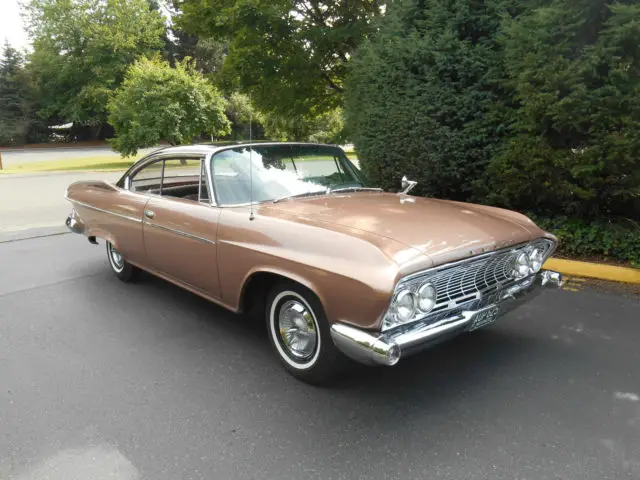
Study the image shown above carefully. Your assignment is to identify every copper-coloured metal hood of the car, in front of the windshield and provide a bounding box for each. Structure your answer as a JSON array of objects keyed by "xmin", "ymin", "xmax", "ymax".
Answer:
[{"xmin": 269, "ymin": 192, "xmax": 545, "ymax": 265}]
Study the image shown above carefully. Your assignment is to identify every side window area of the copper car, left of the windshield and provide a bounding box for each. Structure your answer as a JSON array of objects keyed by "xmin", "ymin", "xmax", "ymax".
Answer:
[{"xmin": 130, "ymin": 158, "xmax": 210, "ymax": 203}]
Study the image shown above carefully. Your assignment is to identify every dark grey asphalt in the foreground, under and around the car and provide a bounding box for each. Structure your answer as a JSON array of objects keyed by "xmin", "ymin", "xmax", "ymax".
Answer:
[{"xmin": 0, "ymin": 235, "xmax": 640, "ymax": 480}]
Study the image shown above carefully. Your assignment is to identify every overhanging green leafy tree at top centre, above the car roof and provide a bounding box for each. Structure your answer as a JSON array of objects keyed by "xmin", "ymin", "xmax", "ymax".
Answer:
[{"xmin": 174, "ymin": 0, "xmax": 384, "ymax": 117}]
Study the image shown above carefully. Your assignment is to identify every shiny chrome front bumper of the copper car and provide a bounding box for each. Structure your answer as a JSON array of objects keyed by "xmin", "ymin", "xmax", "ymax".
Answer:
[{"xmin": 331, "ymin": 270, "xmax": 562, "ymax": 365}]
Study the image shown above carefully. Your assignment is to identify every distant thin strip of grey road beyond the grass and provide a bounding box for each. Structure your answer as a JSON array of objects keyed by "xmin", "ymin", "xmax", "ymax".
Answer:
[{"xmin": 0, "ymin": 147, "xmax": 159, "ymax": 168}]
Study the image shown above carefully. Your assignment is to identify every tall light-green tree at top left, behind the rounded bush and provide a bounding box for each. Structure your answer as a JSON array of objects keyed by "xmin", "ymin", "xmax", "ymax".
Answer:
[{"xmin": 25, "ymin": 0, "xmax": 165, "ymax": 134}]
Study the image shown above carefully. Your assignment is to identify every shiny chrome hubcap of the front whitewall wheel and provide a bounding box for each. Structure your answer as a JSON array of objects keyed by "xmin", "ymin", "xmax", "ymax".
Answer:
[{"xmin": 278, "ymin": 300, "xmax": 318, "ymax": 359}]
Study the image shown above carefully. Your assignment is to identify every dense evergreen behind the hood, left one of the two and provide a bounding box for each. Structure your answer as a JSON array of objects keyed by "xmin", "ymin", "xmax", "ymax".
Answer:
[{"xmin": 345, "ymin": 0, "xmax": 515, "ymax": 199}]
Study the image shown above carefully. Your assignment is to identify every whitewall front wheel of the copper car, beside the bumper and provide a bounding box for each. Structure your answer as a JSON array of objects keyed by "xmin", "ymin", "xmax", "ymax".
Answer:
[{"xmin": 266, "ymin": 282, "xmax": 345, "ymax": 384}]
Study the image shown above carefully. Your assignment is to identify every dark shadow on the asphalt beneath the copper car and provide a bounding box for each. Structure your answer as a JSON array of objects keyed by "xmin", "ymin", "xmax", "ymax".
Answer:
[{"xmin": 136, "ymin": 268, "xmax": 552, "ymax": 400}]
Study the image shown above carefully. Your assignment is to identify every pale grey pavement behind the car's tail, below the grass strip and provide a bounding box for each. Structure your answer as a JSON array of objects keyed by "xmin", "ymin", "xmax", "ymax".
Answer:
[{"xmin": 0, "ymin": 172, "xmax": 122, "ymax": 241}]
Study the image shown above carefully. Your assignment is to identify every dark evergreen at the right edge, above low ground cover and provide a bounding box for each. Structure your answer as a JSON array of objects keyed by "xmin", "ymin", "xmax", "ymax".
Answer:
[{"xmin": 487, "ymin": 0, "xmax": 640, "ymax": 219}]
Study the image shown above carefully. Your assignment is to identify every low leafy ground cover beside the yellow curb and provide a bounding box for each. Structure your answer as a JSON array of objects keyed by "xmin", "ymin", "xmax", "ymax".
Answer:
[{"xmin": 529, "ymin": 215, "xmax": 640, "ymax": 267}]
